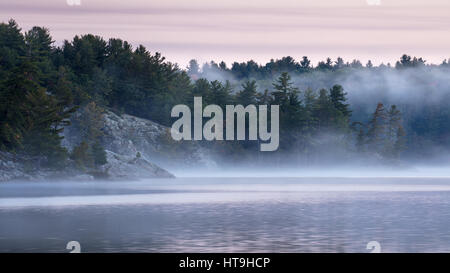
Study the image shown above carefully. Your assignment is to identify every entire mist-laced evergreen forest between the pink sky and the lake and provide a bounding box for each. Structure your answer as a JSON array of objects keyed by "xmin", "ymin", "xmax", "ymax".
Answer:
[{"xmin": 0, "ymin": 20, "xmax": 450, "ymax": 181}]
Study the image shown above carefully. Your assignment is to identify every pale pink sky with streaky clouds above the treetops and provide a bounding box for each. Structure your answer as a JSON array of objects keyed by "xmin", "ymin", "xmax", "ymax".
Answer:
[{"xmin": 0, "ymin": 0, "xmax": 450, "ymax": 68}]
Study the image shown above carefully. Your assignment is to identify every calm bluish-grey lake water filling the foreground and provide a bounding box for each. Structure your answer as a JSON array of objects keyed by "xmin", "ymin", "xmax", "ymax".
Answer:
[{"xmin": 0, "ymin": 178, "xmax": 450, "ymax": 252}]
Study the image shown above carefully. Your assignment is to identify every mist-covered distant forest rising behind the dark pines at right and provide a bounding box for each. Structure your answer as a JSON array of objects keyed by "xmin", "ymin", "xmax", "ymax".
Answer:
[{"xmin": 190, "ymin": 54, "xmax": 450, "ymax": 162}]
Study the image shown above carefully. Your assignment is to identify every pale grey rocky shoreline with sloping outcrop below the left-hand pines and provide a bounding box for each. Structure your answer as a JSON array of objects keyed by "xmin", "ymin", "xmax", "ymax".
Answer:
[{"xmin": 0, "ymin": 107, "xmax": 221, "ymax": 182}]
